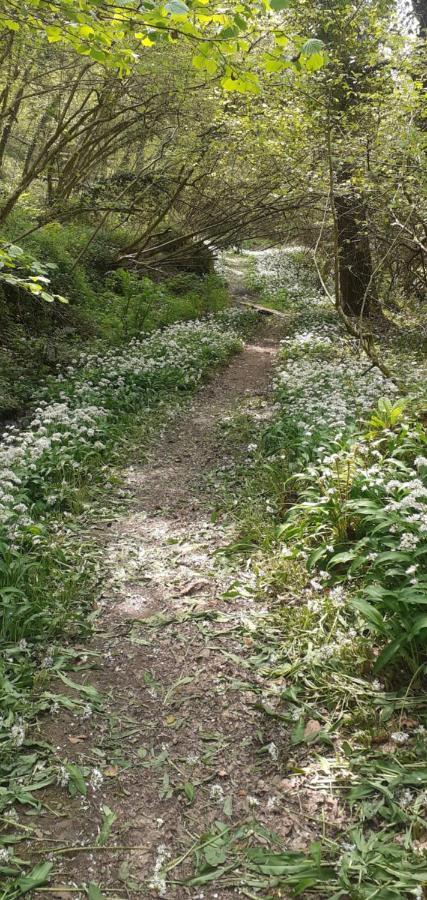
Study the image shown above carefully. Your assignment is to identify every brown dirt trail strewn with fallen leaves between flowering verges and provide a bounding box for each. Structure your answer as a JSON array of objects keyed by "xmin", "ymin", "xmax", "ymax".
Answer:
[{"xmin": 30, "ymin": 321, "xmax": 310, "ymax": 900}]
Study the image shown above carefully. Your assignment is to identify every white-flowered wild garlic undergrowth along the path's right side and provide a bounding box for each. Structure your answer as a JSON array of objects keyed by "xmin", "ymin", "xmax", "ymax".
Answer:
[{"xmin": 198, "ymin": 251, "xmax": 427, "ymax": 900}]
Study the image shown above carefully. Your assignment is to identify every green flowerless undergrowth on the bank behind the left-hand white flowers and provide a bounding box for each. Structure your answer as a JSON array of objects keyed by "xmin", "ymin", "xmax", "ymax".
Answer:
[{"xmin": 0, "ymin": 208, "xmax": 227, "ymax": 420}]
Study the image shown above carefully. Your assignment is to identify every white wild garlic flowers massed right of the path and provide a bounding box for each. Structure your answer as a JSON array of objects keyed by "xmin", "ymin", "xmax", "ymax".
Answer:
[{"xmin": 247, "ymin": 249, "xmax": 427, "ymax": 564}]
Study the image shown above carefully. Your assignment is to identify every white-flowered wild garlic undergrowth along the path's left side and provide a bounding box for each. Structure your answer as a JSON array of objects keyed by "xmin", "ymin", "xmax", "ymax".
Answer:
[{"xmin": 0, "ymin": 309, "xmax": 257, "ymax": 898}]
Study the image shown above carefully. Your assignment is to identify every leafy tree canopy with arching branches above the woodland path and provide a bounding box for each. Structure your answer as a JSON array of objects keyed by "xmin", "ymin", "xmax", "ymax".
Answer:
[{"xmin": 0, "ymin": 0, "xmax": 427, "ymax": 315}]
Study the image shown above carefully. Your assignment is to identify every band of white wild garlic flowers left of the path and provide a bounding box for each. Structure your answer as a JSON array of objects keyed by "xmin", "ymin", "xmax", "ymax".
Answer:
[{"xmin": 0, "ymin": 310, "xmax": 247, "ymax": 543}]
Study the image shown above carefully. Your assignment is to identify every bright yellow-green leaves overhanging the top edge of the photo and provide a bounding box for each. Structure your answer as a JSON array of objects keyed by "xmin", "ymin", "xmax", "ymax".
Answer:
[{"xmin": 0, "ymin": 0, "xmax": 325, "ymax": 81}]
